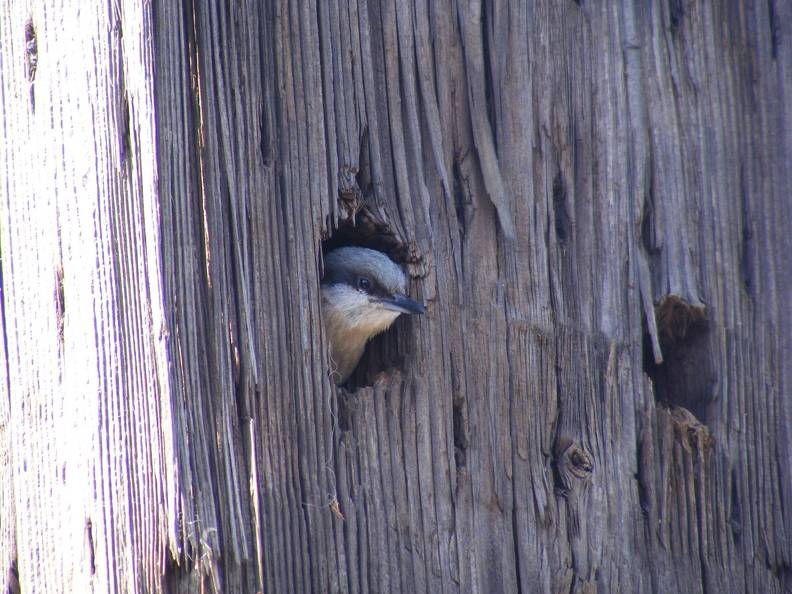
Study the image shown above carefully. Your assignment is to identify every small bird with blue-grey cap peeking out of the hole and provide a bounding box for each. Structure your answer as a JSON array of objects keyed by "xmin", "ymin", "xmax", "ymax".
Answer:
[{"xmin": 321, "ymin": 246, "xmax": 426, "ymax": 385}]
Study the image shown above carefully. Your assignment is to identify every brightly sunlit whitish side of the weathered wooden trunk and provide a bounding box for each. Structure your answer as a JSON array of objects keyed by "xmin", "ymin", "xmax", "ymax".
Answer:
[{"xmin": 0, "ymin": 0, "xmax": 173, "ymax": 594}]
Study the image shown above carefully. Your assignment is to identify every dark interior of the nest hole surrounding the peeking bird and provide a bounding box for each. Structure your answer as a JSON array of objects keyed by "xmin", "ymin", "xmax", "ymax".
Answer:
[{"xmin": 321, "ymin": 207, "xmax": 415, "ymax": 388}]
